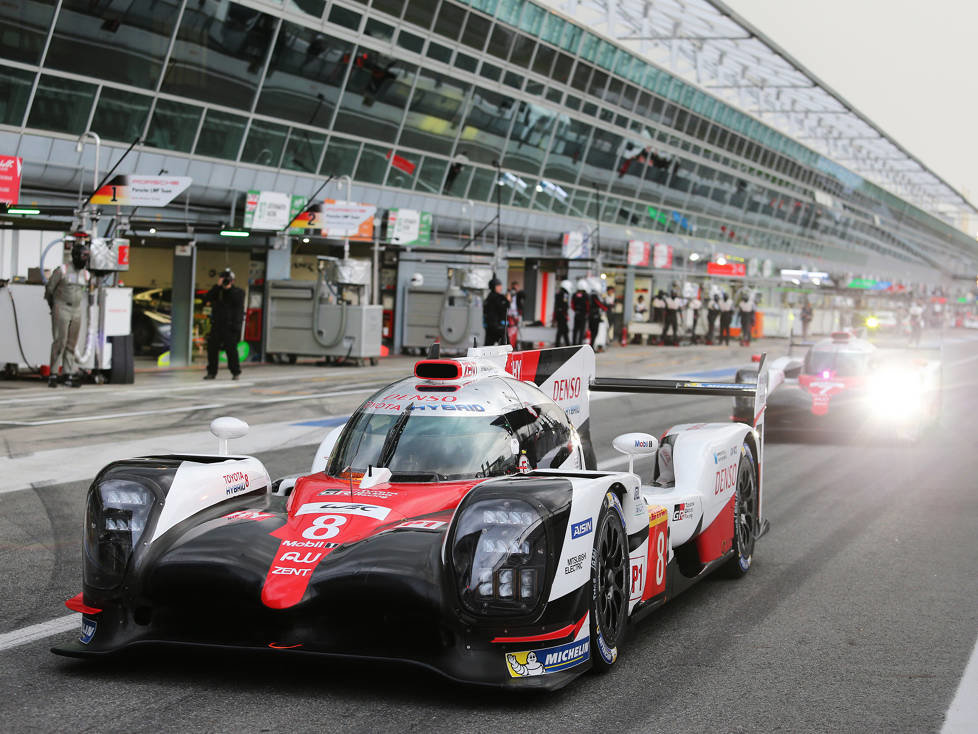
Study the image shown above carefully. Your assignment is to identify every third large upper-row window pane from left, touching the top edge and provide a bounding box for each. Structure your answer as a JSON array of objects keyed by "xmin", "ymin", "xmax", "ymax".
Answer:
[{"xmin": 162, "ymin": 3, "xmax": 278, "ymax": 110}]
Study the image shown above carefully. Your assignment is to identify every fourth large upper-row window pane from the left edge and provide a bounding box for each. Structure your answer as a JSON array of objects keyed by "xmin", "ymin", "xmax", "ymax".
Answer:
[{"xmin": 255, "ymin": 23, "xmax": 353, "ymax": 127}]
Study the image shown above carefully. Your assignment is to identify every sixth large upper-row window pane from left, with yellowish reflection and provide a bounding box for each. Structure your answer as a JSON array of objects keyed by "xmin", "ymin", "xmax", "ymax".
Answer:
[{"xmin": 400, "ymin": 68, "xmax": 469, "ymax": 155}]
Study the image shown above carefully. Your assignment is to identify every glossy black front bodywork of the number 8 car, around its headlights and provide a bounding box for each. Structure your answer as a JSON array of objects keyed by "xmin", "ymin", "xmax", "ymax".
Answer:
[{"xmin": 54, "ymin": 462, "xmax": 590, "ymax": 689}]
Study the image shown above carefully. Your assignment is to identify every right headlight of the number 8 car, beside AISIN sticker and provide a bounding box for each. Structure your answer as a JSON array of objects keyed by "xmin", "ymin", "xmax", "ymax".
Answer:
[{"xmin": 452, "ymin": 499, "xmax": 548, "ymax": 614}]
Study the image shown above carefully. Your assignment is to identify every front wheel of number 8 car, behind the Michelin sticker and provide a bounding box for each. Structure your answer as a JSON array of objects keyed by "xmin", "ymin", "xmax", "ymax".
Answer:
[{"xmin": 588, "ymin": 492, "xmax": 629, "ymax": 673}]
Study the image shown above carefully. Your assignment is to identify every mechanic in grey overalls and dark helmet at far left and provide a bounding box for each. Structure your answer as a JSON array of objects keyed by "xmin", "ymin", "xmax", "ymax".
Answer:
[{"xmin": 44, "ymin": 241, "xmax": 92, "ymax": 387}]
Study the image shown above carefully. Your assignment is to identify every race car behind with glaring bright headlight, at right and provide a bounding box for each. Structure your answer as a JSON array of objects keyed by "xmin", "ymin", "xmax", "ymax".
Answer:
[{"xmin": 733, "ymin": 332, "xmax": 942, "ymax": 440}]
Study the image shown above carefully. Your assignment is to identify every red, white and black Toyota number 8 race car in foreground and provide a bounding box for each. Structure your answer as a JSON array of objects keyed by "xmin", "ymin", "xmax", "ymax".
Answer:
[{"xmin": 53, "ymin": 346, "xmax": 767, "ymax": 689}]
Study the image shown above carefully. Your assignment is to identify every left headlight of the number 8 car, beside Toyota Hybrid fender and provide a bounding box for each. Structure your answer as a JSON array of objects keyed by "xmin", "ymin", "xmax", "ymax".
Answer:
[{"xmin": 84, "ymin": 478, "xmax": 156, "ymax": 589}]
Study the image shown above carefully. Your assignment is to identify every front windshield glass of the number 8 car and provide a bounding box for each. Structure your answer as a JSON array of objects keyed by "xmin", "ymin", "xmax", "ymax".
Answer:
[{"xmin": 329, "ymin": 409, "xmax": 518, "ymax": 482}]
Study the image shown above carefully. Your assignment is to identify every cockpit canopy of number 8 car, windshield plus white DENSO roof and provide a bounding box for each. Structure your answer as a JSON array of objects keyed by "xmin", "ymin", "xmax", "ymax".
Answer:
[{"xmin": 326, "ymin": 377, "xmax": 582, "ymax": 482}]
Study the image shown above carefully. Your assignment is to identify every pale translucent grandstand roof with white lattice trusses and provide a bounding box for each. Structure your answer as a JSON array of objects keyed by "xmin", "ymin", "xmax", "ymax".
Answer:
[{"xmin": 544, "ymin": 0, "xmax": 978, "ymax": 225}]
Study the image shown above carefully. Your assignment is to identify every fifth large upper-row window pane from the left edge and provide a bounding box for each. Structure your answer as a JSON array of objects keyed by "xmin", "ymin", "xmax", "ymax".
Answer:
[{"xmin": 333, "ymin": 46, "xmax": 417, "ymax": 143}]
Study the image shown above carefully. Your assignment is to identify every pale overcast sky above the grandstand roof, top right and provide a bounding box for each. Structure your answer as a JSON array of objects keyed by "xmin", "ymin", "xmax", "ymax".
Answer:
[{"xmin": 725, "ymin": 0, "xmax": 978, "ymax": 217}]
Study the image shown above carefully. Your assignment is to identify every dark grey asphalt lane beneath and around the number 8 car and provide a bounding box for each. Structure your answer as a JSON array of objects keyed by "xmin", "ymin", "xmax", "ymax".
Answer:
[{"xmin": 0, "ymin": 340, "xmax": 978, "ymax": 732}]
